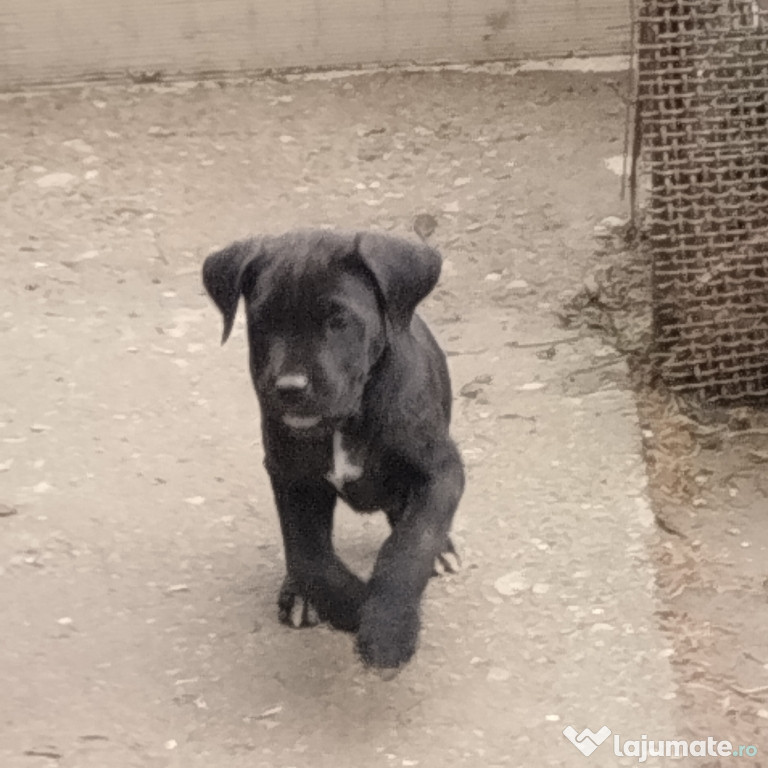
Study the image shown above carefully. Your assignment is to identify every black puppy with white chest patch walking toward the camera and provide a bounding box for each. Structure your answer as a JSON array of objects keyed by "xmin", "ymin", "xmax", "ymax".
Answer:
[{"xmin": 203, "ymin": 230, "xmax": 464, "ymax": 669}]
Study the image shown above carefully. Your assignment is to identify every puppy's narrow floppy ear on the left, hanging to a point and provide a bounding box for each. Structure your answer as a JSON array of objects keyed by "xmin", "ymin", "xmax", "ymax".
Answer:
[{"xmin": 203, "ymin": 234, "xmax": 262, "ymax": 344}]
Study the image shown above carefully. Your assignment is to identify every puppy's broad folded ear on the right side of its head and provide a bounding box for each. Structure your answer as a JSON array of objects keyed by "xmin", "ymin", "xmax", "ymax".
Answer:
[{"xmin": 356, "ymin": 232, "xmax": 442, "ymax": 329}]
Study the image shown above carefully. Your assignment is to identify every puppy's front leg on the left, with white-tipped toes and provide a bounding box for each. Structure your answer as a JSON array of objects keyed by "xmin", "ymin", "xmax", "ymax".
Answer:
[{"xmin": 272, "ymin": 478, "xmax": 365, "ymax": 632}]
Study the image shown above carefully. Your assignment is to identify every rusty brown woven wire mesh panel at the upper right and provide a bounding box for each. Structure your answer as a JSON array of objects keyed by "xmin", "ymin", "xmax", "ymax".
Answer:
[{"xmin": 635, "ymin": 0, "xmax": 768, "ymax": 402}]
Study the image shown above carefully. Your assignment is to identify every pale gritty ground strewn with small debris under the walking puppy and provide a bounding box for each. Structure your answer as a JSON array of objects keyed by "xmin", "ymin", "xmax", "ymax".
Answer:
[{"xmin": 0, "ymin": 73, "xmax": 760, "ymax": 768}]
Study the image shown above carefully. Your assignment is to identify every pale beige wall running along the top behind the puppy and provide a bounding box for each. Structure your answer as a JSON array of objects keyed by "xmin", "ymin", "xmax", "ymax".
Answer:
[{"xmin": 0, "ymin": 0, "xmax": 628, "ymax": 87}]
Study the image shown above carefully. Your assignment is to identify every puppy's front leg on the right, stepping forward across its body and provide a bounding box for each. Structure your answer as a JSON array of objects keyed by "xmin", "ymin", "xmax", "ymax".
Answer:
[{"xmin": 357, "ymin": 445, "xmax": 464, "ymax": 669}]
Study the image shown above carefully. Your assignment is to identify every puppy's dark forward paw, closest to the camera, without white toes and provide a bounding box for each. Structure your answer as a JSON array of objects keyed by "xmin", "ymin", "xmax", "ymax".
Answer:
[{"xmin": 355, "ymin": 599, "xmax": 421, "ymax": 680}]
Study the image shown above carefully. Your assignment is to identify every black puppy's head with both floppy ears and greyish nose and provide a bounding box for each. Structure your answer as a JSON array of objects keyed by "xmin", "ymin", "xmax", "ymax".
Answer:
[{"xmin": 203, "ymin": 230, "xmax": 440, "ymax": 434}]
